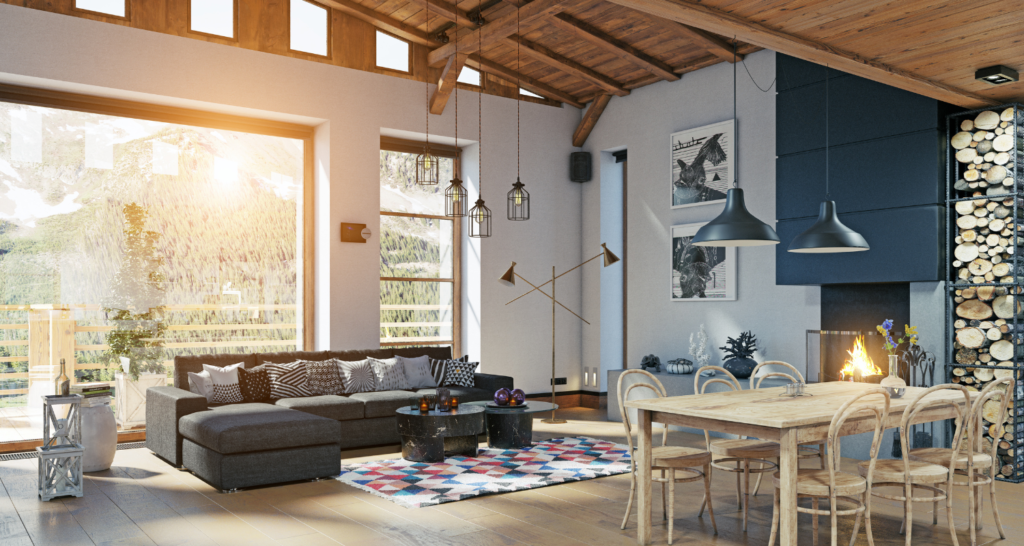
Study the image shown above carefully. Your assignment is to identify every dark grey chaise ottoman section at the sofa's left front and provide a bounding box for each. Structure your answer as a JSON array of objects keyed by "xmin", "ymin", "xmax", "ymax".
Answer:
[{"xmin": 178, "ymin": 404, "xmax": 341, "ymax": 491}]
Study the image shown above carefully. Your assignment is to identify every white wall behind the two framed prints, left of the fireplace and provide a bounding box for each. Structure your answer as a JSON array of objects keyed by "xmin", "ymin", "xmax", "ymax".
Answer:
[{"xmin": 582, "ymin": 51, "xmax": 820, "ymax": 391}]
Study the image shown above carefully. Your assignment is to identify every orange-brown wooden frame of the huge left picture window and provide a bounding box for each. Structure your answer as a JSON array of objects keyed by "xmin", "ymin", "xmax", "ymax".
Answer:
[{"xmin": 0, "ymin": 84, "xmax": 315, "ymax": 350}]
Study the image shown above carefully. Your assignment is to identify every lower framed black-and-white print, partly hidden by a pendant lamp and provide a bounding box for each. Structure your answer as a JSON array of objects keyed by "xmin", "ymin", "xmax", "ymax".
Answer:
[{"xmin": 669, "ymin": 223, "xmax": 737, "ymax": 301}]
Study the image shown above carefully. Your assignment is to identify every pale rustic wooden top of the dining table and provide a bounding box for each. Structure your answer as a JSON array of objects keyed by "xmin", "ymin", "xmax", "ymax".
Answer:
[{"xmin": 626, "ymin": 381, "xmax": 978, "ymax": 429}]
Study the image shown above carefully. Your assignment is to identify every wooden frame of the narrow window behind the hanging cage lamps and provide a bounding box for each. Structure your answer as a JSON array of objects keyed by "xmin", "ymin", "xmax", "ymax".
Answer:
[{"xmin": 378, "ymin": 136, "xmax": 462, "ymax": 358}]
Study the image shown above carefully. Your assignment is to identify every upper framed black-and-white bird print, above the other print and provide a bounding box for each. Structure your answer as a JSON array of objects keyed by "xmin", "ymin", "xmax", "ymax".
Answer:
[{"xmin": 670, "ymin": 120, "xmax": 736, "ymax": 209}]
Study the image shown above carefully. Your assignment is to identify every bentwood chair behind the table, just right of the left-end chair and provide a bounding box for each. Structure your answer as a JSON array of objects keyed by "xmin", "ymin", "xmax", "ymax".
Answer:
[{"xmin": 693, "ymin": 366, "xmax": 780, "ymax": 533}]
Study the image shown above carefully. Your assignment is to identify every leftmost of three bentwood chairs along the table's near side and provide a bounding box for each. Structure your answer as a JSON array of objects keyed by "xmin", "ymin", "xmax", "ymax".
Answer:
[{"xmin": 768, "ymin": 388, "xmax": 889, "ymax": 546}]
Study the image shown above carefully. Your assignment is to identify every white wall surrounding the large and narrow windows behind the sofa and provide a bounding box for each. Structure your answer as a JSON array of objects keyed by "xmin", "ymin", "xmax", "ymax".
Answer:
[{"xmin": 0, "ymin": 4, "xmax": 581, "ymax": 392}]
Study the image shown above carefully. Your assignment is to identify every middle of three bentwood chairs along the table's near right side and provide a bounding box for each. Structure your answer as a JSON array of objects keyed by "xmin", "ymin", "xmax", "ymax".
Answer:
[{"xmin": 858, "ymin": 384, "xmax": 975, "ymax": 546}]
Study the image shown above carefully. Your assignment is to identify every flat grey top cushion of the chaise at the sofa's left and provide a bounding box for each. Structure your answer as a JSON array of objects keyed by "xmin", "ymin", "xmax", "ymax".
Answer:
[{"xmin": 178, "ymin": 404, "xmax": 341, "ymax": 454}]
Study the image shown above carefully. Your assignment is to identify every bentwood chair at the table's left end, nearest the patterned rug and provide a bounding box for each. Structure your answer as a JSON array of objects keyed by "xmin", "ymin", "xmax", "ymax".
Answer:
[{"xmin": 615, "ymin": 370, "xmax": 718, "ymax": 544}]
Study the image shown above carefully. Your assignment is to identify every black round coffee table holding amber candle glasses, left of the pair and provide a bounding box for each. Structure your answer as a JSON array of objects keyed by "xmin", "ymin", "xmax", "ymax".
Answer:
[{"xmin": 395, "ymin": 405, "xmax": 484, "ymax": 463}]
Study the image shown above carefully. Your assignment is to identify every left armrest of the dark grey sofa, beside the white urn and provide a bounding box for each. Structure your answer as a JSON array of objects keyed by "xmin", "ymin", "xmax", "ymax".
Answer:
[{"xmin": 145, "ymin": 387, "xmax": 209, "ymax": 466}]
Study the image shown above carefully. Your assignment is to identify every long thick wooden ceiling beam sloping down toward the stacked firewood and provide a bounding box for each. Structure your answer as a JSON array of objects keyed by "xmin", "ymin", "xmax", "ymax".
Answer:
[{"xmin": 607, "ymin": 0, "xmax": 999, "ymax": 108}]
